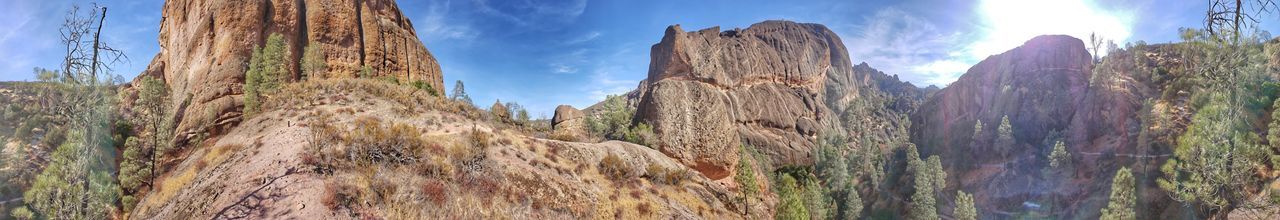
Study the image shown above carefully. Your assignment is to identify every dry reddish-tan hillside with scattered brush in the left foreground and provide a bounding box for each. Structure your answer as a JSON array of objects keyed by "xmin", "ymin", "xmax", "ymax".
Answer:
[{"xmin": 132, "ymin": 79, "xmax": 752, "ymax": 219}]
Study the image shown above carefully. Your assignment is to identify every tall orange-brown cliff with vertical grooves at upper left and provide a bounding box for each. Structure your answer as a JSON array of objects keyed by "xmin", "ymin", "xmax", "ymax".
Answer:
[{"xmin": 135, "ymin": 0, "xmax": 444, "ymax": 145}]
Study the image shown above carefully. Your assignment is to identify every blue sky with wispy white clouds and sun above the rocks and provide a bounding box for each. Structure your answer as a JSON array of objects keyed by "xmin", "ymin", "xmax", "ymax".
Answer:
[{"xmin": 0, "ymin": 0, "xmax": 1277, "ymax": 118}]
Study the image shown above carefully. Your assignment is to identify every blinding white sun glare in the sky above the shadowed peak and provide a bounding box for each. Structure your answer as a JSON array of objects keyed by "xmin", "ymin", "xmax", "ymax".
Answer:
[{"xmin": 969, "ymin": 0, "xmax": 1133, "ymax": 58}]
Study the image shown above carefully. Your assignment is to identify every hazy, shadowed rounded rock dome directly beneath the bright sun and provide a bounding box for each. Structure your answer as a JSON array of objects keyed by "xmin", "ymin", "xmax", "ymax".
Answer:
[{"xmin": 911, "ymin": 36, "xmax": 1093, "ymax": 217}]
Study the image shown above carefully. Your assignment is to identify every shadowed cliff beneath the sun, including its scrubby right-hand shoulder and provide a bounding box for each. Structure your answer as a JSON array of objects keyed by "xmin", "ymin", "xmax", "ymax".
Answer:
[{"xmin": 911, "ymin": 36, "xmax": 1190, "ymax": 219}]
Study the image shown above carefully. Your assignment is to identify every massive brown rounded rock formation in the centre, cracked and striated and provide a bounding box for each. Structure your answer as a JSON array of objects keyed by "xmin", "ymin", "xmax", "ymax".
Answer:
[{"xmin": 636, "ymin": 20, "xmax": 863, "ymax": 179}]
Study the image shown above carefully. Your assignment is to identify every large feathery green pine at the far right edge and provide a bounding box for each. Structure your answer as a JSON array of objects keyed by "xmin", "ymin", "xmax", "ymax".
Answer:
[{"xmin": 1157, "ymin": 29, "xmax": 1275, "ymax": 217}]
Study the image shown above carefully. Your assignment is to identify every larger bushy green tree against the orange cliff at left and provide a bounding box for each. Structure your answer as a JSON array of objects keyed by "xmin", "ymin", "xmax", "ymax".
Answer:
[{"xmin": 244, "ymin": 33, "xmax": 289, "ymax": 115}]
